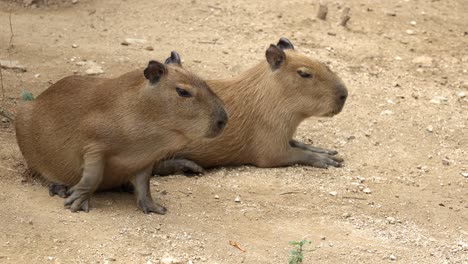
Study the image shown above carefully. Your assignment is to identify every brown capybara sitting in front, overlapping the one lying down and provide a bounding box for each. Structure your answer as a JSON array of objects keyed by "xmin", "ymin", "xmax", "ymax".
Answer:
[{"xmin": 15, "ymin": 52, "xmax": 227, "ymax": 214}]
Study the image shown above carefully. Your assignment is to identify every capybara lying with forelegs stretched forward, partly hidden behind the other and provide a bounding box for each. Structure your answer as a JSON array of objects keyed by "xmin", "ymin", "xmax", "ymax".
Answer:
[{"xmin": 154, "ymin": 38, "xmax": 348, "ymax": 175}]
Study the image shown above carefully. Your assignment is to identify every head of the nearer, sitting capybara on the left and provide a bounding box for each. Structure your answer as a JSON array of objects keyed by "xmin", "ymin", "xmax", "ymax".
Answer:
[{"xmin": 144, "ymin": 51, "xmax": 228, "ymax": 139}]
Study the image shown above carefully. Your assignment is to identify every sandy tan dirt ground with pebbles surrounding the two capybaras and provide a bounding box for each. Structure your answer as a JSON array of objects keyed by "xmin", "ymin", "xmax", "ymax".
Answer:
[{"xmin": 0, "ymin": 0, "xmax": 468, "ymax": 264}]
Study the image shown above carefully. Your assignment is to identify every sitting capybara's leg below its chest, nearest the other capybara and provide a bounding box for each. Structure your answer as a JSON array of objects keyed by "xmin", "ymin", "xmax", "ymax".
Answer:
[{"xmin": 131, "ymin": 168, "xmax": 167, "ymax": 214}]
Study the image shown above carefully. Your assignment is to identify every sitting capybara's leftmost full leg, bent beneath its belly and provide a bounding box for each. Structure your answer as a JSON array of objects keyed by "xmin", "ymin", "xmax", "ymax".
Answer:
[{"xmin": 65, "ymin": 153, "xmax": 104, "ymax": 212}]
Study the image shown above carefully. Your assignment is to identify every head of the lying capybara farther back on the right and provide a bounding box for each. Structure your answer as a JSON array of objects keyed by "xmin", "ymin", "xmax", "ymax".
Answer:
[{"xmin": 266, "ymin": 38, "xmax": 348, "ymax": 117}]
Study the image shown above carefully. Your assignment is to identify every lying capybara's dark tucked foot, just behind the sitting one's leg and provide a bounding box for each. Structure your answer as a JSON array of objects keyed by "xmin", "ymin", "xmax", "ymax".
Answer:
[{"xmin": 153, "ymin": 159, "xmax": 204, "ymax": 176}]
